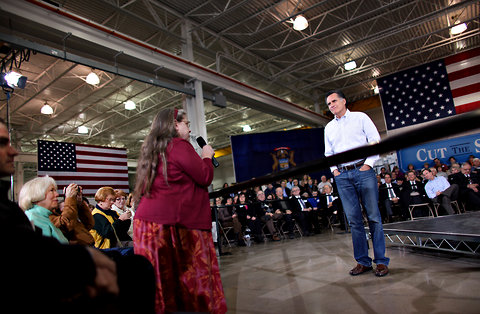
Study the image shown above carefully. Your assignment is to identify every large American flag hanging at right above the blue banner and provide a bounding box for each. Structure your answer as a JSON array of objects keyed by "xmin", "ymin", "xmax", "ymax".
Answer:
[{"xmin": 377, "ymin": 48, "xmax": 480, "ymax": 130}]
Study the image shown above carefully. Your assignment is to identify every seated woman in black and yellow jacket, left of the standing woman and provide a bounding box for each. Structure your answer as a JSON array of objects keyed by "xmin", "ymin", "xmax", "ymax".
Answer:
[{"xmin": 90, "ymin": 187, "xmax": 132, "ymax": 249}]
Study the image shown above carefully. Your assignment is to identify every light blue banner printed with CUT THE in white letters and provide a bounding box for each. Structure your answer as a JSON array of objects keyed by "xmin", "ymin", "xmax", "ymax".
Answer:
[{"xmin": 397, "ymin": 133, "xmax": 480, "ymax": 171}]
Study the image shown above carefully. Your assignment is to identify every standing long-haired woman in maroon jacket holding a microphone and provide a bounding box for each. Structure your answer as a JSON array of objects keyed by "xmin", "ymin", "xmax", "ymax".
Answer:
[{"xmin": 133, "ymin": 109, "xmax": 227, "ymax": 313}]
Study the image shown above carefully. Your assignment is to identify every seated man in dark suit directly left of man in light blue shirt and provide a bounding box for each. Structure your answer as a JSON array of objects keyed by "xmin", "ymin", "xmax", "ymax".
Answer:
[{"xmin": 400, "ymin": 170, "xmax": 428, "ymax": 219}]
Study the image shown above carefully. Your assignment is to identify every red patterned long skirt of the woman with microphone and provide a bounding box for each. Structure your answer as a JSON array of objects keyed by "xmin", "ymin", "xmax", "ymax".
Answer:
[{"xmin": 133, "ymin": 219, "xmax": 227, "ymax": 313}]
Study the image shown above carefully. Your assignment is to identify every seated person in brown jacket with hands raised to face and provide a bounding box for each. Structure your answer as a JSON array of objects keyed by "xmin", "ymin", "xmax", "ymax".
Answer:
[{"xmin": 49, "ymin": 183, "xmax": 95, "ymax": 246}]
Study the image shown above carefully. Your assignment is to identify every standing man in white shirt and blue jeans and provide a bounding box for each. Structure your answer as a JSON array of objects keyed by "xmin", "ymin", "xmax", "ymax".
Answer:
[{"xmin": 325, "ymin": 90, "xmax": 390, "ymax": 277}]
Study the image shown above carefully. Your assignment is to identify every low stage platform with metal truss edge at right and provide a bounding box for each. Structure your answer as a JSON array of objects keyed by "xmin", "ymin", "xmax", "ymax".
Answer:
[{"xmin": 367, "ymin": 212, "xmax": 480, "ymax": 256}]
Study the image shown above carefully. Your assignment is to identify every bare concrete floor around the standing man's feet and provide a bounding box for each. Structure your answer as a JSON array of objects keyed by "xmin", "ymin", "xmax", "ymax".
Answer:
[{"xmin": 219, "ymin": 230, "xmax": 480, "ymax": 314}]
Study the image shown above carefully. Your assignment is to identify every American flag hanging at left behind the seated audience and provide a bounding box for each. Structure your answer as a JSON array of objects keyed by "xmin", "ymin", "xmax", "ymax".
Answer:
[{"xmin": 38, "ymin": 140, "xmax": 129, "ymax": 196}]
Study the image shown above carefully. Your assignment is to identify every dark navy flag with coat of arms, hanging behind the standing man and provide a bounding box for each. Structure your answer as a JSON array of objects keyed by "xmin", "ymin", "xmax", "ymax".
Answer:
[{"xmin": 231, "ymin": 128, "xmax": 330, "ymax": 182}]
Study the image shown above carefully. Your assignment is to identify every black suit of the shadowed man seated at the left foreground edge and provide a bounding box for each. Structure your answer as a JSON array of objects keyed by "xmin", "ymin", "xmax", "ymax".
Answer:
[{"xmin": 0, "ymin": 182, "xmax": 96, "ymax": 313}]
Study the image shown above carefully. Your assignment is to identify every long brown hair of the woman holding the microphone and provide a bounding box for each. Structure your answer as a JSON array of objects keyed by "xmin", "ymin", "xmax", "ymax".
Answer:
[{"xmin": 133, "ymin": 109, "xmax": 185, "ymax": 205}]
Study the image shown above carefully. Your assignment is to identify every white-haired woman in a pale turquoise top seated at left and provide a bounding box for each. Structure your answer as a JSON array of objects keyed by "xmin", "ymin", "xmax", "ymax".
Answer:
[{"xmin": 18, "ymin": 176, "xmax": 68, "ymax": 244}]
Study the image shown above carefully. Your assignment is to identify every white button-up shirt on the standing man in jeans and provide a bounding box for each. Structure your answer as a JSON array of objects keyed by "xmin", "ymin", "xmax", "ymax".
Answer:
[{"xmin": 325, "ymin": 109, "xmax": 380, "ymax": 172}]
